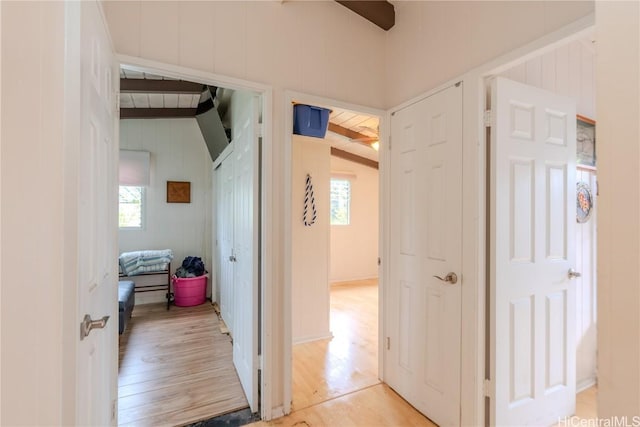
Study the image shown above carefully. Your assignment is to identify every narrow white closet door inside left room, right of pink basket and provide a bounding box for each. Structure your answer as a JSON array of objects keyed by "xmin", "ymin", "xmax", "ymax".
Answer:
[{"xmin": 216, "ymin": 153, "xmax": 234, "ymax": 334}]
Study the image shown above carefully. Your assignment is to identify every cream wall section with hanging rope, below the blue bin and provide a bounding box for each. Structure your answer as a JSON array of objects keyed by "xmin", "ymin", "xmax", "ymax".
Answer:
[{"xmin": 291, "ymin": 135, "xmax": 331, "ymax": 343}]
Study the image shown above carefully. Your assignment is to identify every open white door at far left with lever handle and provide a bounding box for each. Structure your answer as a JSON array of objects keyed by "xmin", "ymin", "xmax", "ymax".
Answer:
[{"xmin": 75, "ymin": 2, "xmax": 118, "ymax": 425}]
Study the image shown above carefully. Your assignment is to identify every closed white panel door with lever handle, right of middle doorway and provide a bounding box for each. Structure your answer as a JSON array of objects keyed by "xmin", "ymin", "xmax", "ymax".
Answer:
[{"xmin": 385, "ymin": 84, "xmax": 462, "ymax": 426}]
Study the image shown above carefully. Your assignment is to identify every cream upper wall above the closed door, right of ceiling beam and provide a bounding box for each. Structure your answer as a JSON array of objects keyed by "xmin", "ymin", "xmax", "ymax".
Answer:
[{"xmin": 385, "ymin": 1, "xmax": 593, "ymax": 107}]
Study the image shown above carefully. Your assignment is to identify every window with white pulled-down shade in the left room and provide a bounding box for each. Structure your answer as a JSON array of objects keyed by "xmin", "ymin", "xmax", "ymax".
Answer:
[{"xmin": 118, "ymin": 150, "xmax": 150, "ymax": 229}]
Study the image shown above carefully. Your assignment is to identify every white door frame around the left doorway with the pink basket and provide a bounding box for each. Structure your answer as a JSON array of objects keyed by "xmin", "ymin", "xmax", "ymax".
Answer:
[{"xmin": 116, "ymin": 55, "xmax": 278, "ymax": 420}]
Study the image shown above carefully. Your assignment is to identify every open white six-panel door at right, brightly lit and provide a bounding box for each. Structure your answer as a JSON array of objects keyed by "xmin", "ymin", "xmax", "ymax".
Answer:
[{"xmin": 489, "ymin": 78, "xmax": 576, "ymax": 426}]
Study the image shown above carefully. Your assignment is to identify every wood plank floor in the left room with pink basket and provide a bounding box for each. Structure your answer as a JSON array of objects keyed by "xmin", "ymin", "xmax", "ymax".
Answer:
[{"xmin": 118, "ymin": 303, "xmax": 248, "ymax": 426}]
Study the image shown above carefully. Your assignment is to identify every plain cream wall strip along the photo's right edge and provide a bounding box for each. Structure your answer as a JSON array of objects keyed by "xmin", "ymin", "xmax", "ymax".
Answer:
[{"xmin": 596, "ymin": 2, "xmax": 640, "ymax": 423}]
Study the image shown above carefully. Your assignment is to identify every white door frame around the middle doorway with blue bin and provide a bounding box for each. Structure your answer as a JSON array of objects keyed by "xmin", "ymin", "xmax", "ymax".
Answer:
[{"xmin": 282, "ymin": 90, "xmax": 389, "ymax": 415}]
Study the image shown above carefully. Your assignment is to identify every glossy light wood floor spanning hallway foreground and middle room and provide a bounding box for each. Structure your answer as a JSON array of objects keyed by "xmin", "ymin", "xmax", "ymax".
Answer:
[{"xmin": 251, "ymin": 280, "xmax": 434, "ymax": 427}]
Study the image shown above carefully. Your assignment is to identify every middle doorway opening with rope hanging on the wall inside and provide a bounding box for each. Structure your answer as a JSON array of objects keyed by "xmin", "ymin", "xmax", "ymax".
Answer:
[{"xmin": 289, "ymin": 96, "xmax": 380, "ymax": 411}]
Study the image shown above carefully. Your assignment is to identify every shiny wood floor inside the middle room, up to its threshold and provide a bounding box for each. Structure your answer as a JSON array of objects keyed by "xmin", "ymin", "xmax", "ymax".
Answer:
[{"xmin": 292, "ymin": 280, "xmax": 380, "ymax": 411}]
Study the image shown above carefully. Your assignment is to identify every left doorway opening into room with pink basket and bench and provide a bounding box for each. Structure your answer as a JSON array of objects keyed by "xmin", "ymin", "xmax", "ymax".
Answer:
[{"xmin": 118, "ymin": 65, "xmax": 265, "ymax": 425}]
